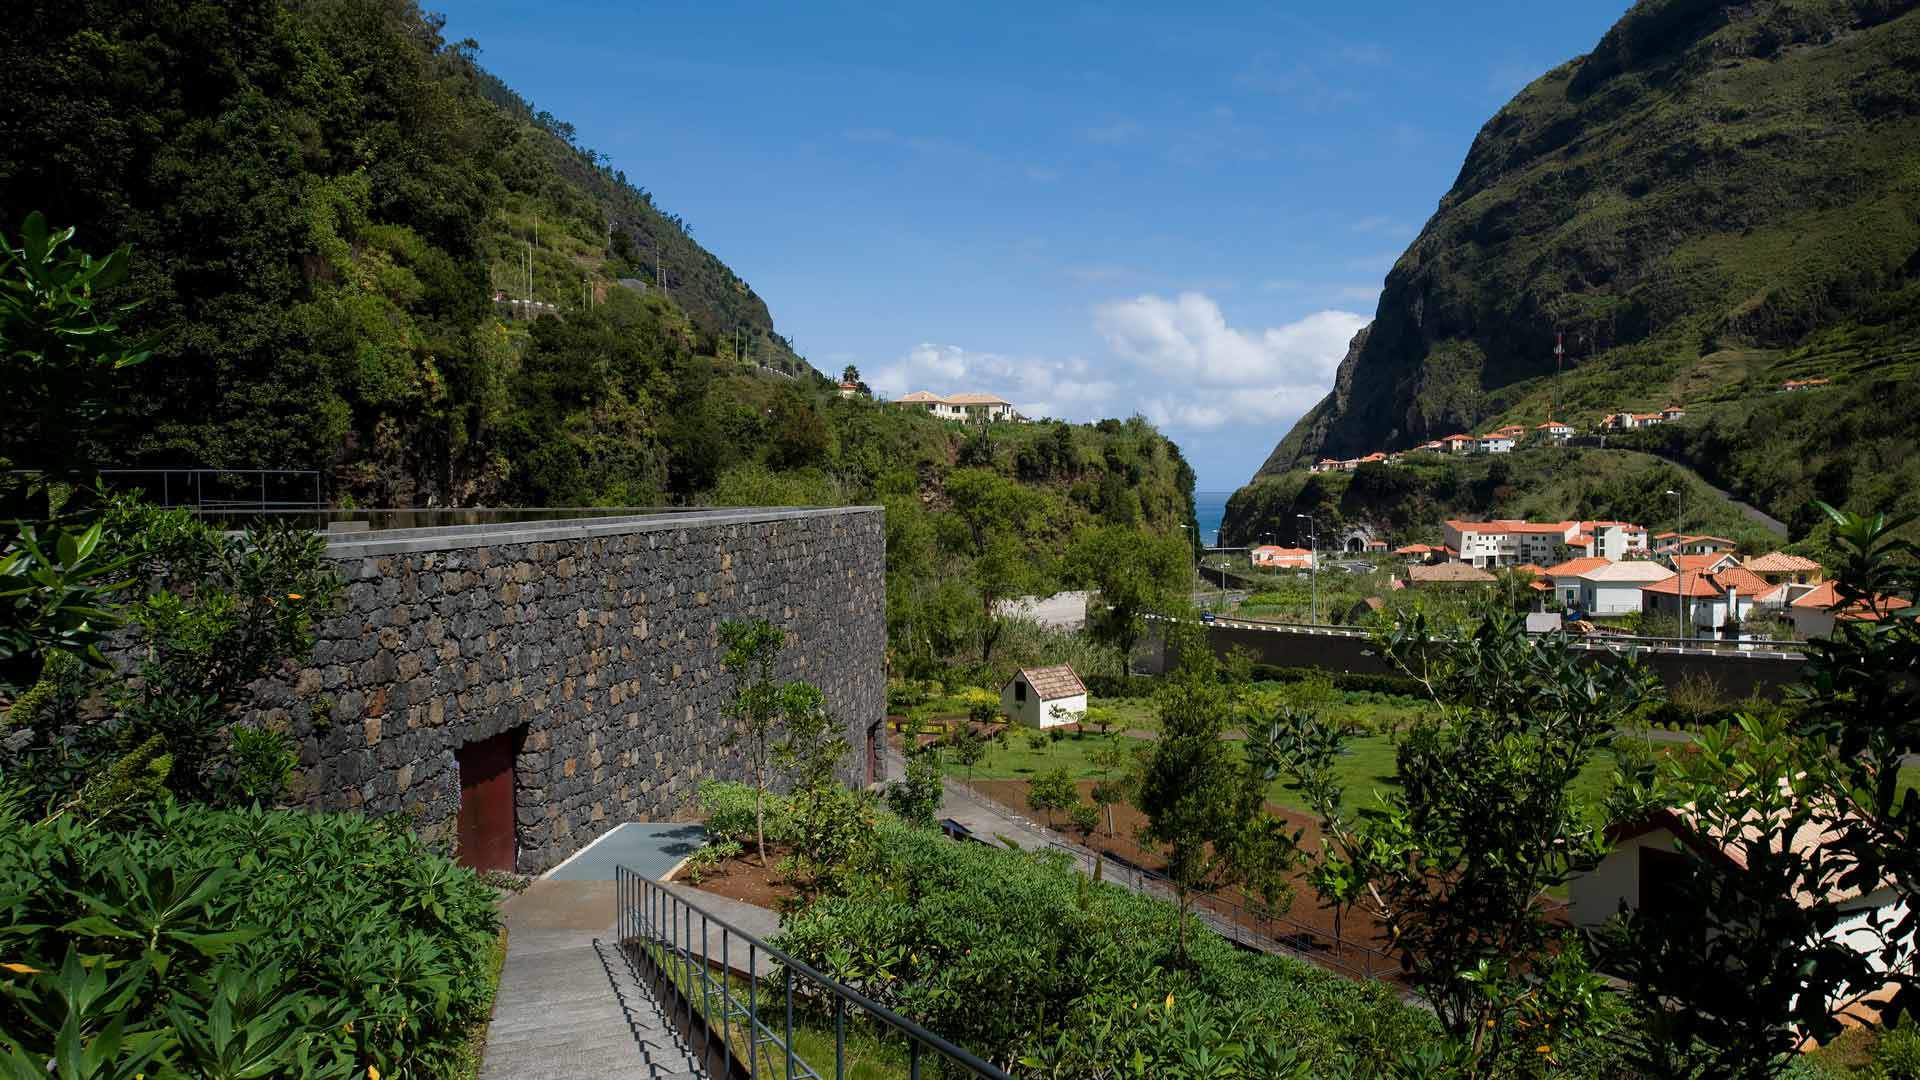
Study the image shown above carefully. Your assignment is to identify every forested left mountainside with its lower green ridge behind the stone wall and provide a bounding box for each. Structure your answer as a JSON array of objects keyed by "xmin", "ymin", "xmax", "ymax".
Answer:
[{"xmin": 0, "ymin": 0, "xmax": 1194, "ymax": 672}]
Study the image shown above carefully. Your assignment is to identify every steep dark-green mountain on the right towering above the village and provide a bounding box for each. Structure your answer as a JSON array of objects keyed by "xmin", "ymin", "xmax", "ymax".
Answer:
[{"xmin": 1260, "ymin": 0, "xmax": 1920, "ymax": 528}]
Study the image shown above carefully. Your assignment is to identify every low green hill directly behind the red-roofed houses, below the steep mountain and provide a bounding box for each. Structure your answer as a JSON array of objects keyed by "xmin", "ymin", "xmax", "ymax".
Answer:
[{"xmin": 1221, "ymin": 448, "xmax": 1780, "ymax": 552}]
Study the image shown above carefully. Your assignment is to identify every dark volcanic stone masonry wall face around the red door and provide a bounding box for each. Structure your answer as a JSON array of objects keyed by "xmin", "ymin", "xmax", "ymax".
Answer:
[{"xmin": 247, "ymin": 507, "xmax": 887, "ymax": 872}]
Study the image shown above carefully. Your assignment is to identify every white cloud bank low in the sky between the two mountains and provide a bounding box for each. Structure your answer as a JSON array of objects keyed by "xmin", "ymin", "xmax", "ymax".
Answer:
[{"xmin": 866, "ymin": 292, "xmax": 1367, "ymax": 432}]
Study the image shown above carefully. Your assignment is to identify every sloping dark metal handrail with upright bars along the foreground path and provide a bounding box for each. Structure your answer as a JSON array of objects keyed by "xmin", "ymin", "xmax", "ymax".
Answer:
[{"xmin": 614, "ymin": 867, "xmax": 1012, "ymax": 1080}]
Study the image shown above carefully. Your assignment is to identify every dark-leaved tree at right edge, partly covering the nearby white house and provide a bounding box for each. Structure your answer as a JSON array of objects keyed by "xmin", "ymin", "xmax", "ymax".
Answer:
[{"xmin": 1607, "ymin": 505, "xmax": 1920, "ymax": 1080}]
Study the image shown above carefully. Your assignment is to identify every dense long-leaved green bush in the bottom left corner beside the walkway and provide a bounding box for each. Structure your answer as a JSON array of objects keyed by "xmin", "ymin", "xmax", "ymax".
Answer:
[{"xmin": 0, "ymin": 801, "xmax": 499, "ymax": 1080}]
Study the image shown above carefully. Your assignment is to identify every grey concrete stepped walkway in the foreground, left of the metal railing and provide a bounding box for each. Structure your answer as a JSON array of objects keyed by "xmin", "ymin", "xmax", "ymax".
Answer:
[{"xmin": 480, "ymin": 914, "xmax": 707, "ymax": 1080}]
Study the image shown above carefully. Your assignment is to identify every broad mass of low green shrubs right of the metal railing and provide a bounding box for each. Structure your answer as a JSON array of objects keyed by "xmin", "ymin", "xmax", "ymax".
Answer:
[{"xmin": 778, "ymin": 822, "xmax": 1436, "ymax": 1076}]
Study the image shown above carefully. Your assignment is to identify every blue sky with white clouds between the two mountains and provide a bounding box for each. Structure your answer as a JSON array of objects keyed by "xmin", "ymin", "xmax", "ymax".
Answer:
[{"xmin": 444, "ymin": 0, "xmax": 1628, "ymax": 490}]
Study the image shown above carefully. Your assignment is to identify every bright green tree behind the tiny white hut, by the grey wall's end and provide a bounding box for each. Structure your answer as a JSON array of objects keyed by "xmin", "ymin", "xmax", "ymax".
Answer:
[{"xmin": 1066, "ymin": 525, "xmax": 1192, "ymax": 675}]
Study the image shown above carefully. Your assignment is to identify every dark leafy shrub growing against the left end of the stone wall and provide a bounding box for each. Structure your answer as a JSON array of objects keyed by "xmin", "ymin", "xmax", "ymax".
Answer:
[{"xmin": 0, "ymin": 496, "xmax": 340, "ymax": 821}]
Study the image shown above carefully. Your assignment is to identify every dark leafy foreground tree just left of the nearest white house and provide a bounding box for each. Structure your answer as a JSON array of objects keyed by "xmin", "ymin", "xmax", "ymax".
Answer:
[{"xmin": 1254, "ymin": 605, "xmax": 1655, "ymax": 1076}]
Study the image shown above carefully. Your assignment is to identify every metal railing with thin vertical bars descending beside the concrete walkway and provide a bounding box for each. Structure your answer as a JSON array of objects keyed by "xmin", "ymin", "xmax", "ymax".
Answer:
[{"xmin": 614, "ymin": 867, "xmax": 1012, "ymax": 1080}]
